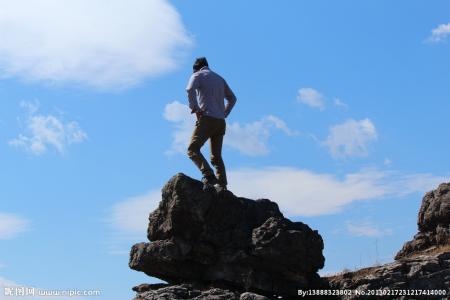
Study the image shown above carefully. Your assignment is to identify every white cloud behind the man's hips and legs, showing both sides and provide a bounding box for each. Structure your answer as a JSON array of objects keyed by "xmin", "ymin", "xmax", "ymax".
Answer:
[{"xmin": 164, "ymin": 101, "xmax": 298, "ymax": 155}]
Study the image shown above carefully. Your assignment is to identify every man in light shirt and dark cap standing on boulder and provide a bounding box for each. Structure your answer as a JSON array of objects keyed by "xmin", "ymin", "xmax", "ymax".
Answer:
[{"xmin": 186, "ymin": 57, "xmax": 236, "ymax": 191}]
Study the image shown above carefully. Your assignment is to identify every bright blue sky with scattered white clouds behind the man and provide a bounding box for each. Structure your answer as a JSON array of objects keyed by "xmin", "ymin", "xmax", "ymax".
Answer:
[{"xmin": 0, "ymin": 0, "xmax": 450, "ymax": 300}]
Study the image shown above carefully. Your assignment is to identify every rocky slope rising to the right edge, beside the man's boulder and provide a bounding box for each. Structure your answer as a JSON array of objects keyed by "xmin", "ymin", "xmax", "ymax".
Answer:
[{"xmin": 327, "ymin": 183, "xmax": 450, "ymax": 299}]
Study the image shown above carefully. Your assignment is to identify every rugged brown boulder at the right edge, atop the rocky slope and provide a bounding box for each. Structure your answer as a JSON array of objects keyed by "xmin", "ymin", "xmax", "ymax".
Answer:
[{"xmin": 395, "ymin": 183, "xmax": 450, "ymax": 259}]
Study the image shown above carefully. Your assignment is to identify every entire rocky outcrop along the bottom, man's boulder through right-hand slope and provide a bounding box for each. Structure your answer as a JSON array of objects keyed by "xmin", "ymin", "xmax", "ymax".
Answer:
[{"xmin": 129, "ymin": 174, "xmax": 450, "ymax": 300}]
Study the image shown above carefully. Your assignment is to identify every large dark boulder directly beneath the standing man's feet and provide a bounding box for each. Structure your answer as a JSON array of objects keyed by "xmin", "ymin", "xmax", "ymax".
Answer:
[{"xmin": 129, "ymin": 174, "xmax": 324, "ymax": 299}]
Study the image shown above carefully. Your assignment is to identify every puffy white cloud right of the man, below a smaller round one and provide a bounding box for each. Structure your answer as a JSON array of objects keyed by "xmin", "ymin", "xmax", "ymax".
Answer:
[{"xmin": 323, "ymin": 119, "xmax": 378, "ymax": 158}]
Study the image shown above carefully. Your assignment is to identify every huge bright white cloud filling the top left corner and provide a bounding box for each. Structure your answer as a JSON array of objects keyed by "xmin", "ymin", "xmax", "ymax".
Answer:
[{"xmin": 0, "ymin": 0, "xmax": 192, "ymax": 88}]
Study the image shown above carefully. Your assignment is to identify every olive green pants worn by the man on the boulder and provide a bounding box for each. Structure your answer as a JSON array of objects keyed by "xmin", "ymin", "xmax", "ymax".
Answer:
[{"xmin": 188, "ymin": 116, "xmax": 227, "ymax": 185}]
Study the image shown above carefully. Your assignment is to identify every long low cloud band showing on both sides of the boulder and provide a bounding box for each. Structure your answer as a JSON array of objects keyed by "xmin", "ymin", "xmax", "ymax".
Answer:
[{"xmin": 107, "ymin": 167, "xmax": 450, "ymax": 220}]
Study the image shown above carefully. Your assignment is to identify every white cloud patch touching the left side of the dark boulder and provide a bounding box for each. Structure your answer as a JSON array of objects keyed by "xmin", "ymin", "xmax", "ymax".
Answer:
[{"xmin": 108, "ymin": 190, "xmax": 161, "ymax": 237}]
